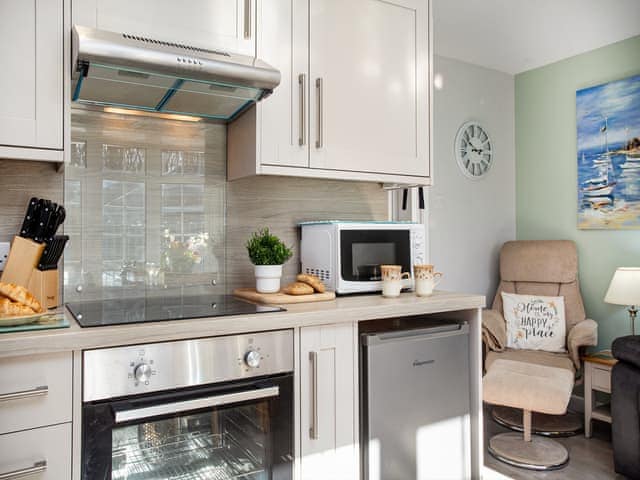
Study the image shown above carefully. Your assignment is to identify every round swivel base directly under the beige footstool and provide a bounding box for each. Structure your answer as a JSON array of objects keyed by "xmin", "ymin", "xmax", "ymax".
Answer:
[{"xmin": 489, "ymin": 432, "xmax": 569, "ymax": 470}]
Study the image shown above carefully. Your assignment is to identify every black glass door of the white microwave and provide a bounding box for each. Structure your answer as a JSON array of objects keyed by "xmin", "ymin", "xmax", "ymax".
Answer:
[{"xmin": 340, "ymin": 229, "xmax": 411, "ymax": 282}]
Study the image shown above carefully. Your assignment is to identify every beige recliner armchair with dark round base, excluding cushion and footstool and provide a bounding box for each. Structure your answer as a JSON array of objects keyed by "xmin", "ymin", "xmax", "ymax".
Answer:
[{"xmin": 482, "ymin": 240, "xmax": 598, "ymax": 436}]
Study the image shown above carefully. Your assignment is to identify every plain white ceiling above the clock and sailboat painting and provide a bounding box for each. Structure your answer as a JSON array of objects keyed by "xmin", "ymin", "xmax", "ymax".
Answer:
[{"xmin": 433, "ymin": 0, "xmax": 640, "ymax": 74}]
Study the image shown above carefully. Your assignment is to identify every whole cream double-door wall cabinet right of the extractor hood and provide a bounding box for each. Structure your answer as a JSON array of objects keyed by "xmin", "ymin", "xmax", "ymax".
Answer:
[{"xmin": 228, "ymin": 0, "xmax": 432, "ymax": 185}]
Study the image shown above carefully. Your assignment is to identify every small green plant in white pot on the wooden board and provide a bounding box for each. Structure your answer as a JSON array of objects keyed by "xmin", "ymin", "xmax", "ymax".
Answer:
[{"xmin": 246, "ymin": 228, "xmax": 293, "ymax": 293}]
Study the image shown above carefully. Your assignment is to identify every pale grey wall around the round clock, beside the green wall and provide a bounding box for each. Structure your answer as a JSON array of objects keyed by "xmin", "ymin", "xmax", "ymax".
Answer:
[{"xmin": 427, "ymin": 56, "xmax": 516, "ymax": 304}]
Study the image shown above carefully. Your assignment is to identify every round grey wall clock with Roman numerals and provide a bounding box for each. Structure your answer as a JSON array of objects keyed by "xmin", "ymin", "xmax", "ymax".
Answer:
[{"xmin": 455, "ymin": 122, "xmax": 493, "ymax": 179}]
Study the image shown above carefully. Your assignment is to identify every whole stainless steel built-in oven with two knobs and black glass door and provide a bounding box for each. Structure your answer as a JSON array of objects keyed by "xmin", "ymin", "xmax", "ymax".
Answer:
[{"xmin": 82, "ymin": 330, "xmax": 294, "ymax": 480}]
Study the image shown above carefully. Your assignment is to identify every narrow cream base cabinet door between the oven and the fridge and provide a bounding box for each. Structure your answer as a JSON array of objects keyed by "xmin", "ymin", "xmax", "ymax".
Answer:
[{"xmin": 300, "ymin": 324, "xmax": 358, "ymax": 480}]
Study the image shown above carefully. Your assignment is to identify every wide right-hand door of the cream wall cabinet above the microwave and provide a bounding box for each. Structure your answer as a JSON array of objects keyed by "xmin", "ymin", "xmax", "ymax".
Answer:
[{"xmin": 309, "ymin": 0, "xmax": 430, "ymax": 177}]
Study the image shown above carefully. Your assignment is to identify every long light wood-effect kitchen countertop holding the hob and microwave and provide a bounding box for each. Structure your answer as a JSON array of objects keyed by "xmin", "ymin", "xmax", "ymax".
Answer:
[{"xmin": 0, "ymin": 291, "xmax": 485, "ymax": 358}]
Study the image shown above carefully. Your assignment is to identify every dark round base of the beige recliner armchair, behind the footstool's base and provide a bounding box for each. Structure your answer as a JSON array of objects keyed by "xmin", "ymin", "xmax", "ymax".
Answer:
[{"xmin": 491, "ymin": 406, "xmax": 582, "ymax": 437}]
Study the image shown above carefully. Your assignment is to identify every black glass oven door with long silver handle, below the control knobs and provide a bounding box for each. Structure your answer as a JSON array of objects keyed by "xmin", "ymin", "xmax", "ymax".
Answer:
[{"xmin": 82, "ymin": 376, "xmax": 293, "ymax": 480}]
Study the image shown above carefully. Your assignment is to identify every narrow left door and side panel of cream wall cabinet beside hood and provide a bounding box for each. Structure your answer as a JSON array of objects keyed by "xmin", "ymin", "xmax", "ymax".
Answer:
[{"xmin": 227, "ymin": 0, "xmax": 309, "ymax": 174}]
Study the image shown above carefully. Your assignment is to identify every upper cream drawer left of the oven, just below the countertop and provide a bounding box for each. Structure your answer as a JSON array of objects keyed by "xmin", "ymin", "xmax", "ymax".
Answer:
[{"xmin": 0, "ymin": 352, "xmax": 72, "ymax": 434}]
